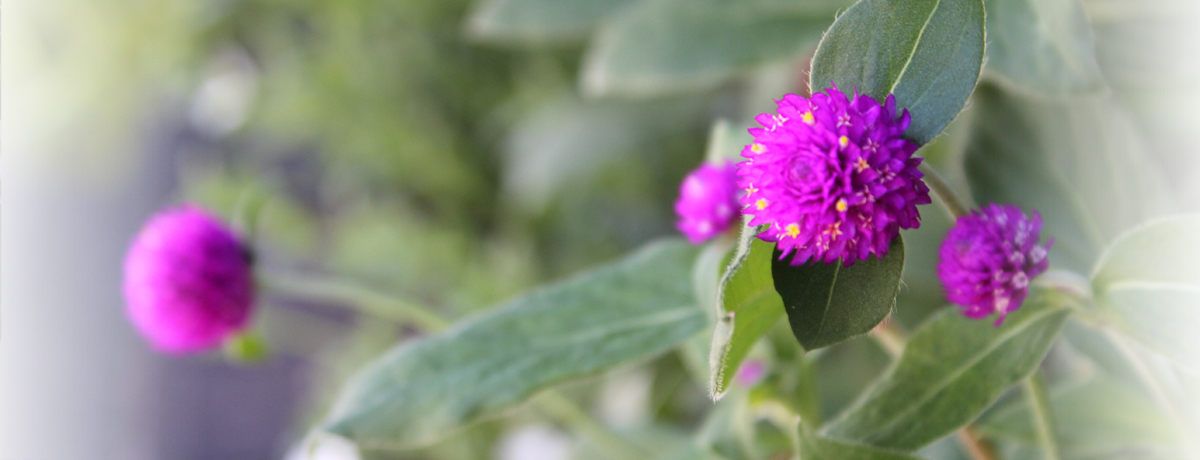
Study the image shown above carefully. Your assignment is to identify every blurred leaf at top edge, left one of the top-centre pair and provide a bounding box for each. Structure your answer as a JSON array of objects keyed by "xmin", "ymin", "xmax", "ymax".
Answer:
[{"xmin": 467, "ymin": 0, "xmax": 634, "ymax": 44}]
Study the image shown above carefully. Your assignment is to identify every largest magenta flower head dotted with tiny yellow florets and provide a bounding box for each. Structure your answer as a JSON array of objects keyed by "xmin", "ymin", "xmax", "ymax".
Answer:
[{"xmin": 738, "ymin": 86, "xmax": 930, "ymax": 265}]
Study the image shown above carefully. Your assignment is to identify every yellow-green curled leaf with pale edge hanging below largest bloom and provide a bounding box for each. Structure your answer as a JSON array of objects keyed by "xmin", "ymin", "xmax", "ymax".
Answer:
[{"xmin": 709, "ymin": 227, "xmax": 784, "ymax": 400}]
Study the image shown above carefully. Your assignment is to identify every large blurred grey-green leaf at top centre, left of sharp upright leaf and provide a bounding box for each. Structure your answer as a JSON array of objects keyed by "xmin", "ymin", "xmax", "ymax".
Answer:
[{"xmin": 581, "ymin": 0, "xmax": 848, "ymax": 97}]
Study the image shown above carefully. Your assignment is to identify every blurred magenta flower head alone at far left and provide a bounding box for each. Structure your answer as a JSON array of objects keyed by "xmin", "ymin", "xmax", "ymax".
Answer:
[{"xmin": 125, "ymin": 205, "xmax": 254, "ymax": 354}]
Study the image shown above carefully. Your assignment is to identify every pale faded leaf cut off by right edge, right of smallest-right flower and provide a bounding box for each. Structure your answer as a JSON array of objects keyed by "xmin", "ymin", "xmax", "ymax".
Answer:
[{"xmin": 1092, "ymin": 216, "xmax": 1200, "ymax": 370}]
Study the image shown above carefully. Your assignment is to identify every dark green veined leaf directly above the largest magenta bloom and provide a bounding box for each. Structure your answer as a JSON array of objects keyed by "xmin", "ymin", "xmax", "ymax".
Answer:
[{"xmin": 809, "ymin": 0, "xmax": 984, "ymax": 144}]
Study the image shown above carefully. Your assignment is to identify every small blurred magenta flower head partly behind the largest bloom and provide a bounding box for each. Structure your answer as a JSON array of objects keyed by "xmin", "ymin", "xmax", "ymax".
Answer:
[{"xmin": 676, "ymin": 161, "xmax": 740, "ymax": 244}]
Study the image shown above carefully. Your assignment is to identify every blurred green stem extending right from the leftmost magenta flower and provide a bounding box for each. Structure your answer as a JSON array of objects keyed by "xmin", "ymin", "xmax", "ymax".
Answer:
[{"xmin": 258, "ymin": 273, "xmax": 450, "ymax": 333}]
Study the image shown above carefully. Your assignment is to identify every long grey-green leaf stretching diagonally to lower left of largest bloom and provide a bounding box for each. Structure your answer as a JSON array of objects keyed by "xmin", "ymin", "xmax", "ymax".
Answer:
[{"xmin": 324, "ymin": 240, "xmax": 706, "ymax": 448}]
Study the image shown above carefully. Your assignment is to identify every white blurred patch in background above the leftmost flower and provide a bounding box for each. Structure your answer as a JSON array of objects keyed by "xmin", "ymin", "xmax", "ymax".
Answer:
[{"xmin": 187, "ymin": 48, "xmax": 258, "ymax": 138}]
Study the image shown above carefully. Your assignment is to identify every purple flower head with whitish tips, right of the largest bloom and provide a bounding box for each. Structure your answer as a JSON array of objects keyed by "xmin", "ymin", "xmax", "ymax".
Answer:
[{"xmin": 937, "ymin": 204, "xmax": 1054, "ymax": 325}]
